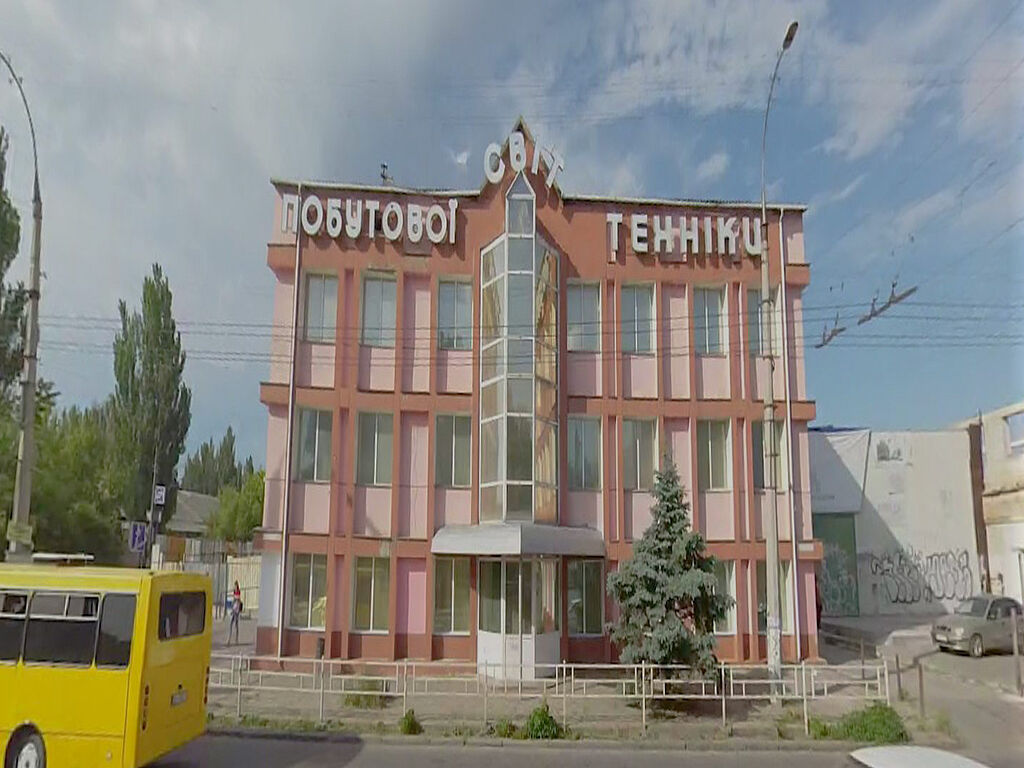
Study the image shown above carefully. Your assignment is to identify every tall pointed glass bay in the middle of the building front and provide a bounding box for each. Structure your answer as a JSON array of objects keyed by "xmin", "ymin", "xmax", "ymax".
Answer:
[{"xmin": 479, "ymin": 175, "xmax": 558, "ymax": 523}]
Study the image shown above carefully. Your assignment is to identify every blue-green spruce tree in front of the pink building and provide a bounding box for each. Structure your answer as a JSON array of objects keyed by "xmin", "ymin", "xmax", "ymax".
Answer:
[{"xmin": 608, "ymin": 456, "xmax": 732, "ymax": 672}]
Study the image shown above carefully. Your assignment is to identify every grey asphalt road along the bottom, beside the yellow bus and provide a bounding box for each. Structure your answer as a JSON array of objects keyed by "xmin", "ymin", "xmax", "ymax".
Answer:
[{"xmin": 152, "ymin": 736, "xmax": 864, "ymax": 768}]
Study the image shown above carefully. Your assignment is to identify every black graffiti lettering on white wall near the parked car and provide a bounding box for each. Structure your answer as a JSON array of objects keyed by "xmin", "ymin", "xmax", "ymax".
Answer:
[{"xmin": 869, "ymin": 547, "xmax": 974, "ymax": 605}]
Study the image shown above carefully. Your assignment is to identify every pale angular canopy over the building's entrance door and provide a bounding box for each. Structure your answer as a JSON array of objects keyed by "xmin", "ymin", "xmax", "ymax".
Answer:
[{"xmin": 430, "ymin": 522, "xmax": 604, "ymax": 557}]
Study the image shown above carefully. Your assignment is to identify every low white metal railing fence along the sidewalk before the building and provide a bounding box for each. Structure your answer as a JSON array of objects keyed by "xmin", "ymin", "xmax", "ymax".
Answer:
[{"xmin": 210, "ymin": 654, "xmax": 890, "ymax": 732}]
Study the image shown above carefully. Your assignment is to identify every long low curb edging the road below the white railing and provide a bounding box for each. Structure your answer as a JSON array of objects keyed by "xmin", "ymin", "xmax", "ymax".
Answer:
[{"xmin": 206, "ymin": 727, "xmax": 864, "ymax": 753}]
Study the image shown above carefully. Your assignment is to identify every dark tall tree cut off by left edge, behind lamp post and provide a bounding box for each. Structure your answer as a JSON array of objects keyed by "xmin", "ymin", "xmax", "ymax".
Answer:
[{"xmin": 0, "ymin": 128, "xmax": 28, "ymax": 410}]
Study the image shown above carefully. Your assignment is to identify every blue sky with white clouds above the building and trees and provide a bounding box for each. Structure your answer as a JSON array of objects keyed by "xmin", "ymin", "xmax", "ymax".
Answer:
[{"xmin": 0, "ymin": 0, "xmax": 1024, "ymax": 464}]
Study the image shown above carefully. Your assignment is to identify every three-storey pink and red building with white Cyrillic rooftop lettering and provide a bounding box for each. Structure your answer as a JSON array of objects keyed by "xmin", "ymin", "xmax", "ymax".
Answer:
[{"xmin": 257, "ymin": 122, "xmax": 821, "ymax": 675}]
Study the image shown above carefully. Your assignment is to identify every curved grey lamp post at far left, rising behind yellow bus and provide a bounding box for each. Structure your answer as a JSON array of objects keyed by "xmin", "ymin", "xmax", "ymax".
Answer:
[{"xmin": 0, "ymin": 51, "xmax": 43, "ymax": 560}]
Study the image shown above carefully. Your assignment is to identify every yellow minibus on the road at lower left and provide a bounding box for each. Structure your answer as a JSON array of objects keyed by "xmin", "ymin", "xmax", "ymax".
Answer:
[{"xmin": 0, "ymin": 563, "xmax": 212, "ymax": 768}]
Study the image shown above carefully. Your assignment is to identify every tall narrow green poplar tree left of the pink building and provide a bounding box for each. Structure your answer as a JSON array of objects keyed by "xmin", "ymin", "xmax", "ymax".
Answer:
[{"xmin": 114, "ymin": 264, "xmax": 191, "ymax": 520}]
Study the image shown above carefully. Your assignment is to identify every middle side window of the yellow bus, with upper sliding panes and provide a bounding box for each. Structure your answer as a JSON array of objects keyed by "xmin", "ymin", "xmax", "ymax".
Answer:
[{"xmin": 24, "ymin": 592, "xmax": 99, "ymax": 666}]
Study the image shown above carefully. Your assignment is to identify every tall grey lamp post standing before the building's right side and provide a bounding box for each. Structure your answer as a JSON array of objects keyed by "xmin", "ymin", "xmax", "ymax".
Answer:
[{"xmin": 761, "ymin": 22, "xmax": 799, "ymax": 693}]
